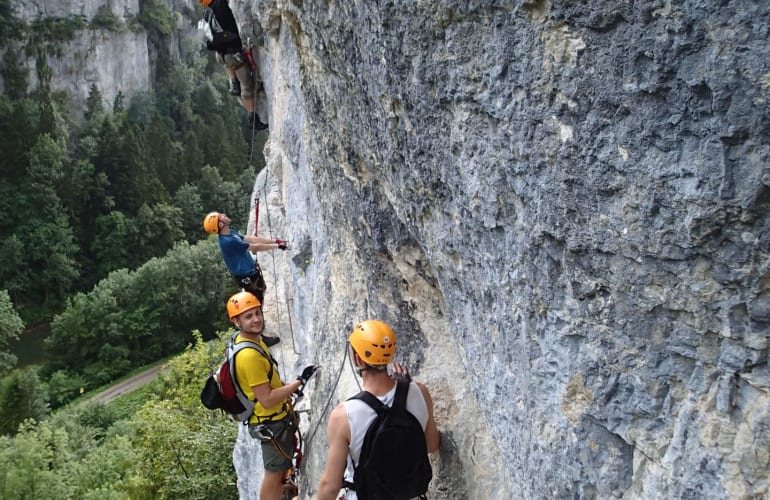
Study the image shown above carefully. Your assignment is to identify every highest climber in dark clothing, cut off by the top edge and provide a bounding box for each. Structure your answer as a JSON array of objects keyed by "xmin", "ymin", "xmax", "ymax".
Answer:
[{"xmin": 198, "ymin": 0, "xmax": 268, "ymax": 130}]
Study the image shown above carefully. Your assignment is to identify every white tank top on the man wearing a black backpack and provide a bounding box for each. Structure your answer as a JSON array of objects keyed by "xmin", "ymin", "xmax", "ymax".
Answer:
[{"xmin": 342, "ymin": 382, "xmax": 428, "ymax": 494}]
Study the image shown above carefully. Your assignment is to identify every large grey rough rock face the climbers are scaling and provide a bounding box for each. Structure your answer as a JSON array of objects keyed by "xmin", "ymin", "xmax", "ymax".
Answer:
[{"xmin": 231, "ymin": 0, "xmax": 770, "ymax": 499}]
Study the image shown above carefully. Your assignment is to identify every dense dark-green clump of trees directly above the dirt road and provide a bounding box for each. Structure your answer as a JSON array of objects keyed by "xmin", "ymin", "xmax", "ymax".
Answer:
[{"xmin": 45, "ymin": 238, "xmax": 231, "ymax": 398}]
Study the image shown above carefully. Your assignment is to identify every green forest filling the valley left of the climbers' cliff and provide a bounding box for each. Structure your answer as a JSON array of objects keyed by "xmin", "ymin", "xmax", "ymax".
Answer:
[{"xmin": 0, "ymin": 0, "xmax": 266, "ymax": 499}]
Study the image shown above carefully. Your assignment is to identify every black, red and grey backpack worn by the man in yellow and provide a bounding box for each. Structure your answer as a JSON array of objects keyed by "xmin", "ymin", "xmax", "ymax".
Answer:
[{"xmin": 201, "ymin": 332, "xmax": 277, "ymax": 422}]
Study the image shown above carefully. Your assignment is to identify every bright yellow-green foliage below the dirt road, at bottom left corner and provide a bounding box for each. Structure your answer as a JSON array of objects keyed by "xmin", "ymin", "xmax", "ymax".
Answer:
[{"xmin": 0, "ymin": 332, "xmax": 238, "ymax": 500}]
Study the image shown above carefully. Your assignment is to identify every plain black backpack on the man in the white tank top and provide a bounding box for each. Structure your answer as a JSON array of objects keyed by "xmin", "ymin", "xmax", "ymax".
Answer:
[{"xmin": 350, "ymin": 382, "xmax": 433, "ymax": 500}]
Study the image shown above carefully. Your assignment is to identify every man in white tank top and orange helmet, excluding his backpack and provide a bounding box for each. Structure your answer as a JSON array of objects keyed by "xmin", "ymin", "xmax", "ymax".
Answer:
[{"xmin": 317, "ymin": 320, "xmax": 439, "ymax": 500}]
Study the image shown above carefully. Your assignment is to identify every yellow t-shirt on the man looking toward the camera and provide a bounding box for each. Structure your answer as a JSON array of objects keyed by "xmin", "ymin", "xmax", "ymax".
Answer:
[{"xmin": 235, "ymin": 333, "xmax": 286, "ymax": 423}]
